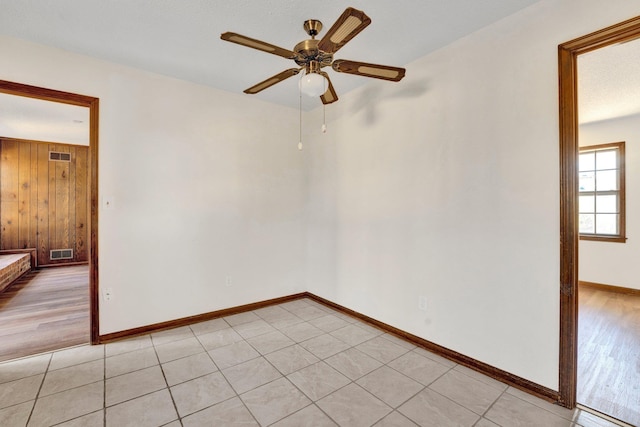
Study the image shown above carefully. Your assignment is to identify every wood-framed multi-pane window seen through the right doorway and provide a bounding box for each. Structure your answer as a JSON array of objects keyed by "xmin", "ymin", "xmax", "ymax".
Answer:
[{"xmin": 578, "ymin": 142, "xmax": 626, "ymax": 243}]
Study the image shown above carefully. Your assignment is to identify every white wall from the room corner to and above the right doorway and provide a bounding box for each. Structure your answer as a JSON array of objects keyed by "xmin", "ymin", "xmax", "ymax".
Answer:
[{"xmin": 307, "ymin": 0, "xmax": 639, "ymax": 390}]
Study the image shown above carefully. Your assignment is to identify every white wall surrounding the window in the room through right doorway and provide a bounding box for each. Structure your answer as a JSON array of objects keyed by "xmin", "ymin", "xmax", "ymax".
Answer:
[{"xmin": 578, "ymin": 115, "xmax": 640, "ymax": 289}]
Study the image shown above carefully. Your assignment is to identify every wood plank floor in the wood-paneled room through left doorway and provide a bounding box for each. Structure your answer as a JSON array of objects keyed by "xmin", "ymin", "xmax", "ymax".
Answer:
[{"xmin": 0, "ymin": 265, "xmax": 89, "ymax": 361}]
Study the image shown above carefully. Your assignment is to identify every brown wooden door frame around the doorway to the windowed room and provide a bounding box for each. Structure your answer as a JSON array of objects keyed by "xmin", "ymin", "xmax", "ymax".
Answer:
[{"xmin": 558, "ymin": 16, "xmax": 640, "ymax": 409}]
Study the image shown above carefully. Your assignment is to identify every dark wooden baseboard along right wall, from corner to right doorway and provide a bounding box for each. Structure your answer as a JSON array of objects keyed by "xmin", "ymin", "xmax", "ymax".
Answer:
[{"xmin": 307, "ymin": 293, "xmax": 560, "ymax": 403}]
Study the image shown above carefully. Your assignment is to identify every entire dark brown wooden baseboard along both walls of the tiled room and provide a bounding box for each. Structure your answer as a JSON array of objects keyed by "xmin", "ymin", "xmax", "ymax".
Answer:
[{"xmin": 98, "ymin": 292, "xmax": 560, "ymax": 403}]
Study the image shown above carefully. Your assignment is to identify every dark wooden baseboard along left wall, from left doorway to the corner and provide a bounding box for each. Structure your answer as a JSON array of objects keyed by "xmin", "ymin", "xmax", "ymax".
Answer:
[{"xmin": 96, "ymin": 293, "xmax": 307, "ymax": 344}]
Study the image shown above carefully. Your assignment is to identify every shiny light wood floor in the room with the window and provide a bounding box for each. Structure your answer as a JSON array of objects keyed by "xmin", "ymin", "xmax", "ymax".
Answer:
[{"xmin": 578, "ymin": 286, "xmax": 640, "ymax": 426}]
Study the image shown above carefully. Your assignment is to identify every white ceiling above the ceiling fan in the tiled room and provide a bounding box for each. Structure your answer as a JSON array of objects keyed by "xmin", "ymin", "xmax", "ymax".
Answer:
[{"xmin": 0, "ymin": 0, "xmax": 538, "ymax": 109}]
